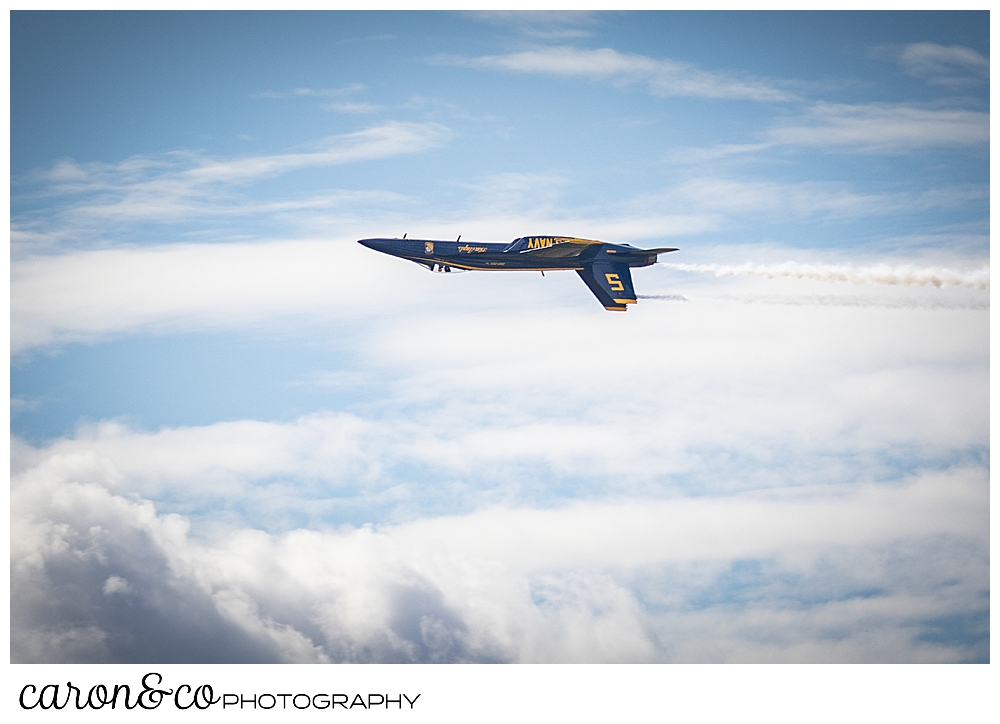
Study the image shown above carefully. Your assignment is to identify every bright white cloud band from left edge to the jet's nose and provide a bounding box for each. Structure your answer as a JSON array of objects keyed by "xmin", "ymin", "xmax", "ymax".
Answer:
[{"xmin": 11, "ymin": 240, "xmax": 430, "ymax": 353}]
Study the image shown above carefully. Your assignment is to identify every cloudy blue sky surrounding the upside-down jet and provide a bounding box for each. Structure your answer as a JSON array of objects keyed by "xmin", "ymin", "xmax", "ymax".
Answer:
[{"xmin": 11, "ymin": 12, "xmax": 989, "ymax": 663}]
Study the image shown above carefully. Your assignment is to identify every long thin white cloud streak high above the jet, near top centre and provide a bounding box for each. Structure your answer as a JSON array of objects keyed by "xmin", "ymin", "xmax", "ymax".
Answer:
[{"xmin": 434, "ymin": 46, "xmax": 794, "ymax": 101}]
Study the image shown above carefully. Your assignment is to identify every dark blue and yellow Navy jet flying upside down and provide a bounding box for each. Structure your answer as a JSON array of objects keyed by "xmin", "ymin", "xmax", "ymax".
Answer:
[{"xmin": 358, "ymin": 234, "xmax": 677, "ymax": 312}]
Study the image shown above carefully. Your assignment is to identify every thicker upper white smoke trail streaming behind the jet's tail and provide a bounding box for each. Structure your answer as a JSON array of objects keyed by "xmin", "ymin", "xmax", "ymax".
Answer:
[{"xmin": 661, "ymin": 261, "xmax": 990, "ymax": 289}]
